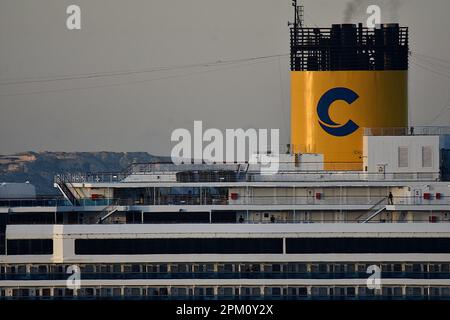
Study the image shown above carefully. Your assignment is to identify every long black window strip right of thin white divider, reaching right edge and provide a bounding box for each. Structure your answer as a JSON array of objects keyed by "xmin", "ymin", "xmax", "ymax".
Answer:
[{"xmin": 286, "ymin": 238, "xmax": 450, "ymax": 253}]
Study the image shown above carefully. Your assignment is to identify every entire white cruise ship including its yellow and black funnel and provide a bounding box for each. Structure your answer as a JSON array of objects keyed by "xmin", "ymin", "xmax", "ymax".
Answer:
[{"xmin": 0, "ymin": 6, "xmax": 450, "ymax": 300}]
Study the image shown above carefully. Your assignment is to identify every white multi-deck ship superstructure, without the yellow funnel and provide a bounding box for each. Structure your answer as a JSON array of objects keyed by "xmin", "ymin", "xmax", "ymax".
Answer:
[{"xmin": 0, "ymin": 132, "xmax": 450, "ymax": 299}]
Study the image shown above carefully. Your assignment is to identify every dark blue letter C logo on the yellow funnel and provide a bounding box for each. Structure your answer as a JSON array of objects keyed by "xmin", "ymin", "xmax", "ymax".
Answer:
[{"xmin": 317, "ymin": 88, "xmax": 359, "ymax": 137}]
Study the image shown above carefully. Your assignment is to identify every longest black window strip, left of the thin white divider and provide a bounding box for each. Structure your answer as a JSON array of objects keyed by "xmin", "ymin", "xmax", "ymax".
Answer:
[{"xmin": 75, "ymin": 238, "xmax": 283, "ymax": 255}]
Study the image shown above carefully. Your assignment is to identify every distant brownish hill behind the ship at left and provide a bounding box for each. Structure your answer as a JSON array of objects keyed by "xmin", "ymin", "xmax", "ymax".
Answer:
[{"xmin": 0, "ymin": 152, "xmax": 170, "ymax": 195}]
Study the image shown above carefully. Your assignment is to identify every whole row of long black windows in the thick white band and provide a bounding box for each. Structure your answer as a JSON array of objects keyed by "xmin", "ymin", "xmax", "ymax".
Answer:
[{"xmin": 7, "ymin": 238, "xmax": 450, "ymax": 255}]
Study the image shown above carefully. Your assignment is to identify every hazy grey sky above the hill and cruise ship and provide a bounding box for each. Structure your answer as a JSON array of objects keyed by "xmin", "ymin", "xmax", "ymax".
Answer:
[{"xmin": 0, "ymin": 0, "xmax": 450, "ymax": 154}]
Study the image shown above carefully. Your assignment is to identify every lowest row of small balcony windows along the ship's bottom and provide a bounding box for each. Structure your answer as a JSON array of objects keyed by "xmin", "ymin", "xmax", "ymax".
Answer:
[{"xmin": 0, "ymin": 286, "xmax": 450, "ymax": 299}]
